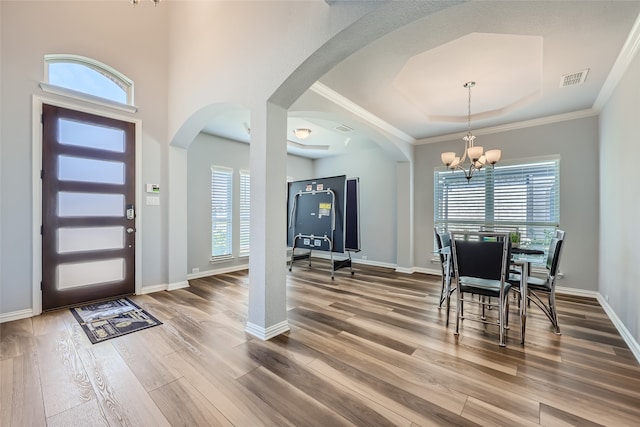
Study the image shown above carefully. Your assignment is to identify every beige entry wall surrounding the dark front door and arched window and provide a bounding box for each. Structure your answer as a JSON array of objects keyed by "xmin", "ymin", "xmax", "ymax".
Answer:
[{"xmin": 0, "ymin": 2, "xmax": 168, "ymax": 313}]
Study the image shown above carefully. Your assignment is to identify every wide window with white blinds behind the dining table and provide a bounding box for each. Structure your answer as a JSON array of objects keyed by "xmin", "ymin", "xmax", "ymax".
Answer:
[{"xmin": 434, "ymin": 159, "xmax": 560, "ymax": 249}]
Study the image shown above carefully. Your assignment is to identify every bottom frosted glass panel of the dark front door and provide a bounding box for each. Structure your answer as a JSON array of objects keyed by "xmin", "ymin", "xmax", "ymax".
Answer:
[{"xmin": 57, "ymin": 258, "xmax": 124, "ymax": 289}]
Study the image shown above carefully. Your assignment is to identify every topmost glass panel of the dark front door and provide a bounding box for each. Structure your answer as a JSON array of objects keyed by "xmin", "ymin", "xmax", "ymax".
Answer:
[{"xmin": 58, "ymin": 119, "xmax": 125, "ymax": 153}]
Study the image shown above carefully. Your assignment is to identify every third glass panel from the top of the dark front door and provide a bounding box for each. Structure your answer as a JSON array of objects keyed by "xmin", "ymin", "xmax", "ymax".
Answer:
[{"xmin": 58, "ymin": 191, "xmax": 124, "ymax": 217}]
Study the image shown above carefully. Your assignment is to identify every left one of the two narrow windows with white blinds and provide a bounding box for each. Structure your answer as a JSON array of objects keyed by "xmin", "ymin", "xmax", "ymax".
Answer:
[{"xmin": 211, "ymin": 166, "xmax": 233, "ymax": 260}]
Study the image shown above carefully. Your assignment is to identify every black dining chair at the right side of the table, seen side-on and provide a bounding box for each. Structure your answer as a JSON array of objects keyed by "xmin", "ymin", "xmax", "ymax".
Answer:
[{"xmin": 509, "ymin": 230, "xmax": 566, "ymax": 335}]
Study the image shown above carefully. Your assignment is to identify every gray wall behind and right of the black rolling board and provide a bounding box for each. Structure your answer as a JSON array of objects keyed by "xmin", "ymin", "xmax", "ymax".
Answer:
[{"xmin": 314, "ymin": 145, "xmax": 397, "ymax": 266}]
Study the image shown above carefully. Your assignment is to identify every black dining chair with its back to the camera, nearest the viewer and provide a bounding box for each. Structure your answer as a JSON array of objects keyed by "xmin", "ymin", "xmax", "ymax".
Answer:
[{"xmin": 451, "ymin": 232, "xmax": 511, "ymax": 347}]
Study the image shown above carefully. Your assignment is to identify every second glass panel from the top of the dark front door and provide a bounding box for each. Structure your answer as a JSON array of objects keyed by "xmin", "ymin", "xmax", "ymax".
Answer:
[{"xmin": 58, "ymin": 156, "xmax": 124, "ymax": 185}]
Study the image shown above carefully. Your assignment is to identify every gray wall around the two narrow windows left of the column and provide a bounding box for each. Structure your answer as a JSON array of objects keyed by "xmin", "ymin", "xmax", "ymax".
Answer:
[{"xmin": 187, "ymin": 133, "xmax": 314, "ymax": 274}]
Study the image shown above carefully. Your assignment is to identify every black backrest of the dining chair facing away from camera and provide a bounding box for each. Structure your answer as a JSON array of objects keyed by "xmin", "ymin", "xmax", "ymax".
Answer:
[{"xmin": 451, "ymin": 232, "xmax": 511, "ymax": 281}]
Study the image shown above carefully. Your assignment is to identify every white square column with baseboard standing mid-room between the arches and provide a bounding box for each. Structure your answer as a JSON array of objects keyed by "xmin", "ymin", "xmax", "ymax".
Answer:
[{"xmin": 246, "ymin": 103, "xmax": 289, "ymax": 340}]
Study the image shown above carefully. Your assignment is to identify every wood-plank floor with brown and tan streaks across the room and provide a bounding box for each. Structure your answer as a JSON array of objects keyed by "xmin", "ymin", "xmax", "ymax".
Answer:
[{"xmin": 0, "ymin": 260, "xmax": 640, "ymax": 427}]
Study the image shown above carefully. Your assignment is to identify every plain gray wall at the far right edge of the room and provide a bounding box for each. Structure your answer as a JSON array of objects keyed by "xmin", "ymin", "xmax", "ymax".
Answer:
[{"xmin": 599, "ymin": 49, "xmax": 640, "ymax": 342}]
